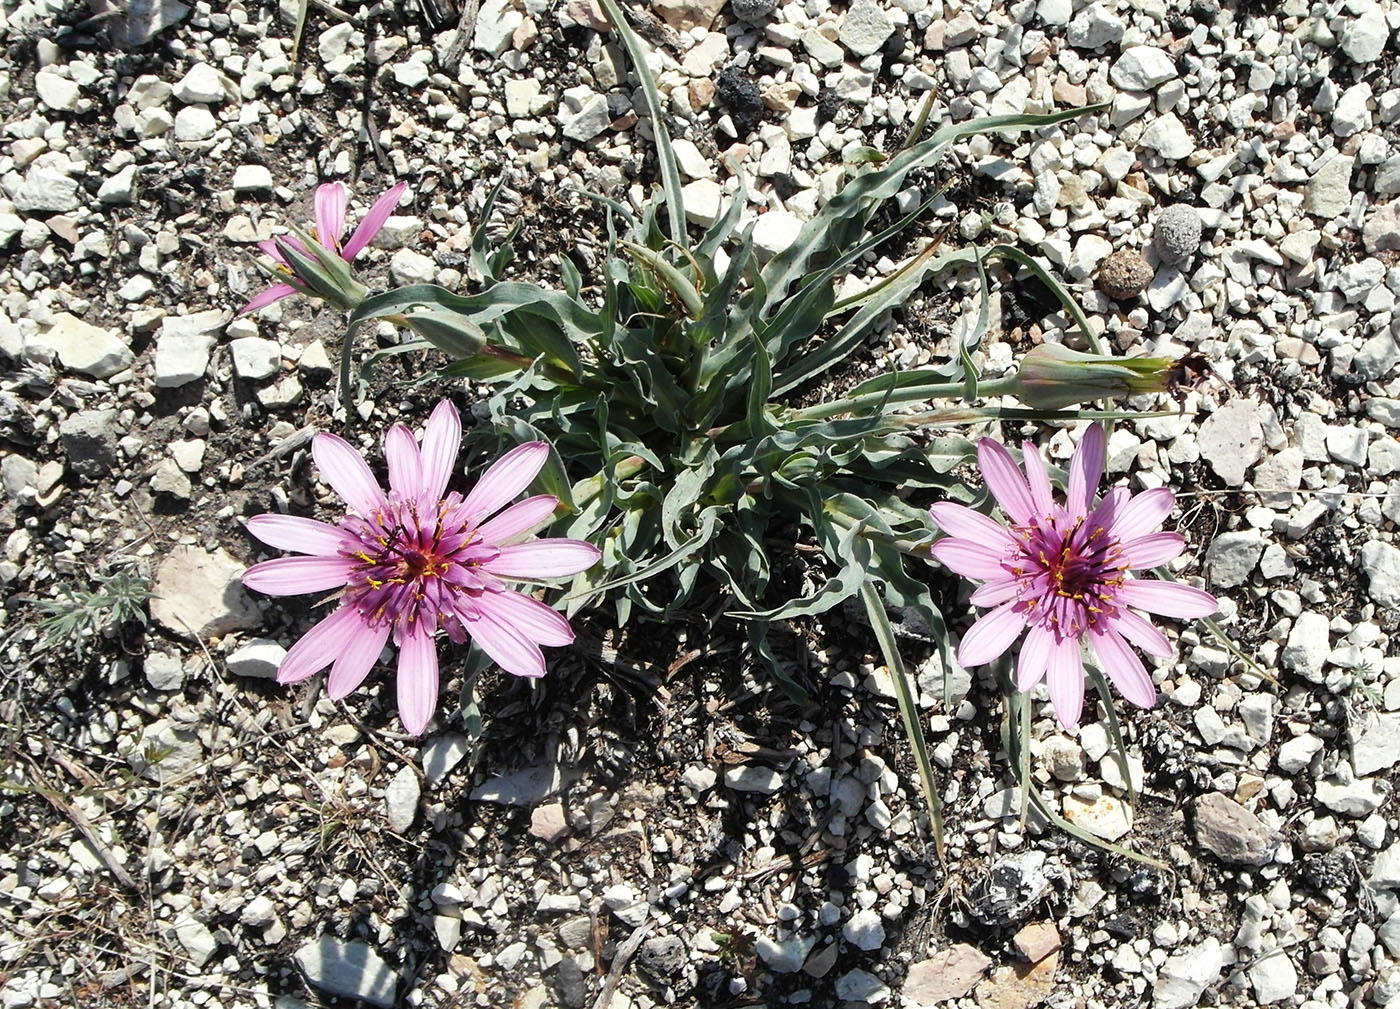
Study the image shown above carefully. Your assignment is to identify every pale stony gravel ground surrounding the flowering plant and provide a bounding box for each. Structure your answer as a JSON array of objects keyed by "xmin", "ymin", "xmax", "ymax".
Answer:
[{"xmin": 0, "ymin": 0, "xmax": 1400, "ymax": 1009}]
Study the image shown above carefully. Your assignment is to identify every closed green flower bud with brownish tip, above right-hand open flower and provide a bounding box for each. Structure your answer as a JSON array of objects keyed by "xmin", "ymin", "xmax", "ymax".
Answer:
[{"xmin": 1015, "ymin": 343, "xmax": 1180, "ymax": 410}]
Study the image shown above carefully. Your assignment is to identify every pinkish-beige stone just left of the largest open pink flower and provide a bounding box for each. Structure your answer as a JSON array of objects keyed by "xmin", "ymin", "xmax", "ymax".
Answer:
[{"xmin": 151, "ymin": 544, "xmax": 262, "ymax": 638}]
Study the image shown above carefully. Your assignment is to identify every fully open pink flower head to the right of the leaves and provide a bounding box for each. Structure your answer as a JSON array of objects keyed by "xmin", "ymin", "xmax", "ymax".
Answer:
[{"xmin": 930, "ymin": 424, "xmax": 1215, "ymax": 726}]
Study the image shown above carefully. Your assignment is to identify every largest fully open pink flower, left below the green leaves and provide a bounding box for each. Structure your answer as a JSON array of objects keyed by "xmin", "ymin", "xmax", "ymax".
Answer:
[{"xmin": 244, "ymin": 400, "xmax": 599, "ymax": 735}]
